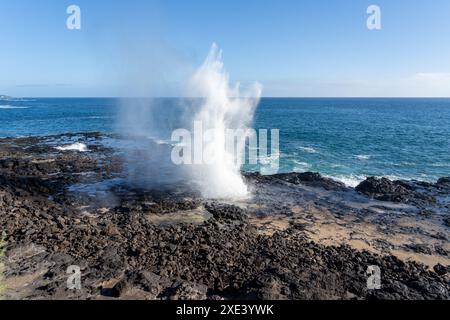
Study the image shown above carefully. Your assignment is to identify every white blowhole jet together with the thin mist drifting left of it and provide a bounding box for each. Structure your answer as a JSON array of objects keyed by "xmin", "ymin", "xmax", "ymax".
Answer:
[{"xmin": 119, "ymin": 44, "xmax": 261, "ymax": 198}]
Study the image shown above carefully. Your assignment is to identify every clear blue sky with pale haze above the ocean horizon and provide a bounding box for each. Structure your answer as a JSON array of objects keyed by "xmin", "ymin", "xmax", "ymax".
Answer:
[{"xmin": 0, "ymin": 0, "xmax": 450, "ymax": 97}]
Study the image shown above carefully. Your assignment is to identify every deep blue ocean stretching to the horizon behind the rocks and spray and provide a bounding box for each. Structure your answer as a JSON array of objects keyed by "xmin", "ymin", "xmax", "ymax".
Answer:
[{"xmin": 0, "ymin": 98, "xmax": 450, "ymax": 184}]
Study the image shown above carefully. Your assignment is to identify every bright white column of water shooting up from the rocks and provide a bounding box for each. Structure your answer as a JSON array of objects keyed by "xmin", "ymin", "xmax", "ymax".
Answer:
[{"xmin": 188, "ymin": 44, "xmax": 262, "ymax": 198}]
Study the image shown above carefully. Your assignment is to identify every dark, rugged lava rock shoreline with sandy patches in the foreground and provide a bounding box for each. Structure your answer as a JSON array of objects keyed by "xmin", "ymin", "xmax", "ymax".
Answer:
[{"xmin": 0, "ymin": 133, "xmax": 450, "ymax": 299}]
